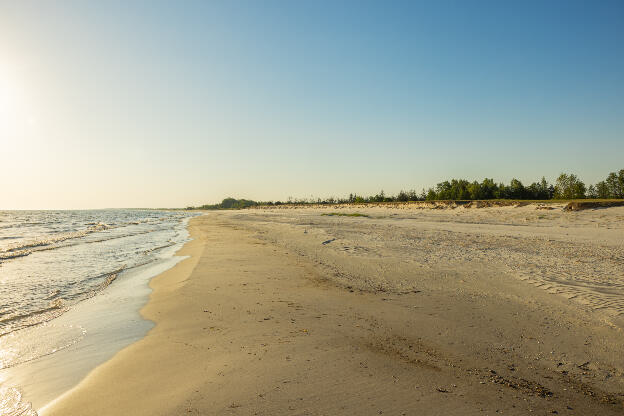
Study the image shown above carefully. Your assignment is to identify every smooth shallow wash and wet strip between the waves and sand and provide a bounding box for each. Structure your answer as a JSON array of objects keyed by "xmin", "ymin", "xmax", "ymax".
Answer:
[{"xmin": 0, "ymin": 216, "xmax": 194, "ymax": 413}]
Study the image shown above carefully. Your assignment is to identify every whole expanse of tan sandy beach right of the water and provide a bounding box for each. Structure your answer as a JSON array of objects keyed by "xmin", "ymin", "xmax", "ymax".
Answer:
[{"xmin": 42, "ymin": 205, "xmax": 624, "ymax": 416}]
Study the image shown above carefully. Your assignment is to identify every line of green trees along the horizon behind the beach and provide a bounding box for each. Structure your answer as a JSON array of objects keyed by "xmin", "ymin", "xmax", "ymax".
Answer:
[{"xmin": 187, "ymin": 169, "xmax": 624, "ymax": 209}]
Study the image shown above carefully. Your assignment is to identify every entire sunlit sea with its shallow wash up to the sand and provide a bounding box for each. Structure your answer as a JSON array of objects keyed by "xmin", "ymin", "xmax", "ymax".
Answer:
[{"xmin": 0, "ymin": 209, "xmax": 196, "ymax": 416}]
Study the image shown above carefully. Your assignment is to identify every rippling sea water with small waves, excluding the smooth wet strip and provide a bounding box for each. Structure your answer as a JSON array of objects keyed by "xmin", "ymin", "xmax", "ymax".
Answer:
[{"xmin": 0, "ymin": 210, "xmax": 193, "ymax": 414}]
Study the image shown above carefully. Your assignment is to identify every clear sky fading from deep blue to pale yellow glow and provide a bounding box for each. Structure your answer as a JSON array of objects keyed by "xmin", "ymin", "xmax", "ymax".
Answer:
[{"xmin": 0, "ymin": 0, "xmax": 624, "ymax": 209}]
